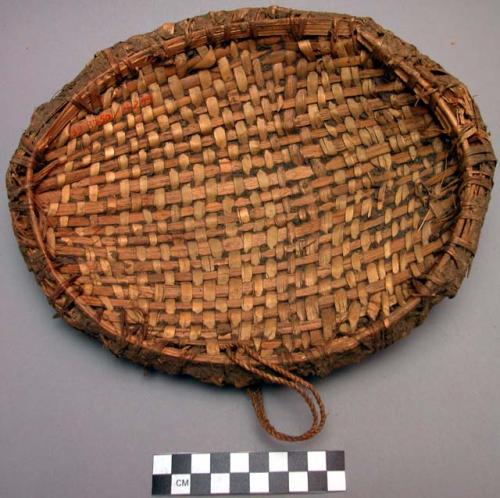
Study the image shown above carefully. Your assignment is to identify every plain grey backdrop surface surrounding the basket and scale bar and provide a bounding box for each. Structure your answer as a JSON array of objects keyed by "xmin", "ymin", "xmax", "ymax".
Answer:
[{"xmin": 0, "ymin": 0, "xmax": 500, "ymax": 498}]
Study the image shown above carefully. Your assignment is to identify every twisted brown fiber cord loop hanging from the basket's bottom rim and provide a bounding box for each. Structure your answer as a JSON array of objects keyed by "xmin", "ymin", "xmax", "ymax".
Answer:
[{"xmin": 226, "ymin": 344, "xmax": 326, "ymax": 442}]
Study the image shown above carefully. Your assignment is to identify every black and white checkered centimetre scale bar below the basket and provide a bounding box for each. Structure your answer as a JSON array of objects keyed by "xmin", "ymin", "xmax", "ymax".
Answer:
[{"xmin": 152, "ymin": 451, "xmax": 346, "ymax": 496}]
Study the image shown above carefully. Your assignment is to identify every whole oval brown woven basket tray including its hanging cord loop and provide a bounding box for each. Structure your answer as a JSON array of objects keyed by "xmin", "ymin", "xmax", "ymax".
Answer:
[{"xmin": 7, "ymin": 7, "xmax": 495, "ymax": 439}]
